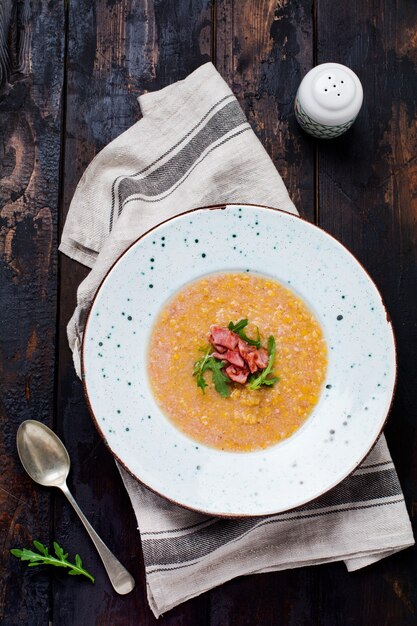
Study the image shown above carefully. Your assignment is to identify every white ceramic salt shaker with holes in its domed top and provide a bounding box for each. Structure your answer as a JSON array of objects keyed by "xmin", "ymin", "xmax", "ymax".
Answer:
[{"xmin": 294, "ymin": 63, "xmax": 363, "ymax": 139}]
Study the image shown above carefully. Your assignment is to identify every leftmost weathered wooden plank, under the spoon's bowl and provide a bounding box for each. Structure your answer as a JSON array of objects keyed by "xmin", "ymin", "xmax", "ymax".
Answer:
[{"xmin": 0, "ymin": 0, "xmax": 65, "ymax": 626}]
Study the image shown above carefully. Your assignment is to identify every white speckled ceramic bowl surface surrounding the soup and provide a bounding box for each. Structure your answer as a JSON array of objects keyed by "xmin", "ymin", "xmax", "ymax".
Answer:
[{"xmin": 82, "ymin": 205, "xmax": 396, "ymax": 516}]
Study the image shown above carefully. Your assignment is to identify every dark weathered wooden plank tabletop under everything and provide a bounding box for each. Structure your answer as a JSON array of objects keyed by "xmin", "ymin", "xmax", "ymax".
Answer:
[{"xmin": 0, "ymin": 0, "xmax": 417, "ymax": 626}]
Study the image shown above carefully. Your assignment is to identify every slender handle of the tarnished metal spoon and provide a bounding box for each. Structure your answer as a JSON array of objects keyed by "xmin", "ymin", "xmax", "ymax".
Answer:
[{"xmin": 59, "ymin": 484, "xmax": 135, "ymax": 595}]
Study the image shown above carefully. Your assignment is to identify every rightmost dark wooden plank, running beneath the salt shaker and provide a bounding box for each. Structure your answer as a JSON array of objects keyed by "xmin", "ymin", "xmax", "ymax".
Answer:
[{"xmin": 317, "ymin": 0, "xmax": 417, "ymax": 626}]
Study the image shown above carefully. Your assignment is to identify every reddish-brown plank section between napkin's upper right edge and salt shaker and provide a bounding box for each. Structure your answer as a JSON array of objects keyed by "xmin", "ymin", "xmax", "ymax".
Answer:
[{"xmin": 216, "ymin": 0, "xmax": 314, "ymax": 220}]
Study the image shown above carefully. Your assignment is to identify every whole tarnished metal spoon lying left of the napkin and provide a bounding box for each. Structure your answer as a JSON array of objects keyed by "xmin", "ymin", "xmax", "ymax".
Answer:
[{"xmin": 16, "ymin": 420, "xmax": 135, "ymax": 594}]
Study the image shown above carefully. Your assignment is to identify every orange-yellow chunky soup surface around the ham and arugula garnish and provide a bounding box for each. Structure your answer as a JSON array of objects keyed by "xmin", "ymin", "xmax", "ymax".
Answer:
[{"xmin": 148, "ymin": 272, "xmax": 327, "ymax": 452}]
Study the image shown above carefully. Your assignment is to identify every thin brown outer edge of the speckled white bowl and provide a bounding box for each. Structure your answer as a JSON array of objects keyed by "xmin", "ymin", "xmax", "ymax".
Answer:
[{"xmin": 81, "ymin": 202, "xmax": 398, "ymax": 519}]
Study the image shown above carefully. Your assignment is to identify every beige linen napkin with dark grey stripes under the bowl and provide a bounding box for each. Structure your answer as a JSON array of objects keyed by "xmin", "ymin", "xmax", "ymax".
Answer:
[{"xmin": 60, "ymin": 63, "xmax": 414, "ymax": 616}]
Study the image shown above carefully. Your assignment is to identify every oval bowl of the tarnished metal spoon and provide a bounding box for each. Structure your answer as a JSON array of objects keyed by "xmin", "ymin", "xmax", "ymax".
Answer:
[{"xmin": 16, "ymin": 420, "xmax": 70, "ymax": 487}]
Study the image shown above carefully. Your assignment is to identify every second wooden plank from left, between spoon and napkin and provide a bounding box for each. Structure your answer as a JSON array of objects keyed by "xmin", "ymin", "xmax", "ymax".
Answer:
[{"xmin": 53, "ymin": 0, "xmax": 211, "ymax": 626}]
